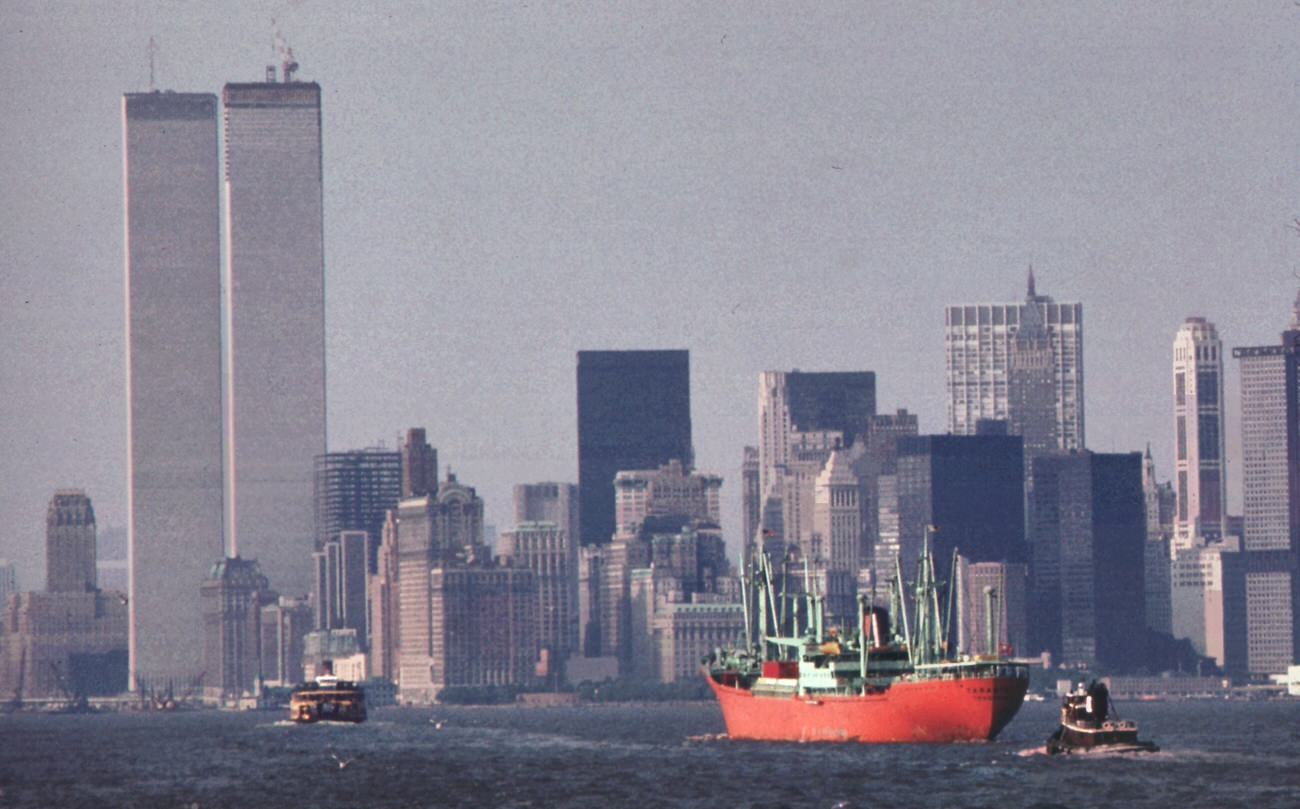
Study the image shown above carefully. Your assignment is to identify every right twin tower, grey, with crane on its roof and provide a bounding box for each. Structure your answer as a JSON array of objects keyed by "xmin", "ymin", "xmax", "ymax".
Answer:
[{"xmin": 222, "ymin": 72, "xmax": 325, "ymax": 596}]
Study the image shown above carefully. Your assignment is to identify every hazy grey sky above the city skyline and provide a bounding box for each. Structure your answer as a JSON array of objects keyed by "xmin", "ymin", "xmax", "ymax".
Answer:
[{"xmin": 0, "ymin": 0, "xmax": 1300, "ymax": 587}]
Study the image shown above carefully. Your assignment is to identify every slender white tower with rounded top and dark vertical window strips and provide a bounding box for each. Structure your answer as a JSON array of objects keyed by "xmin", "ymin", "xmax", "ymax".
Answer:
[{"xmin": 1174, "ymin": 317, "xmax": 1227, "ymax": 549}]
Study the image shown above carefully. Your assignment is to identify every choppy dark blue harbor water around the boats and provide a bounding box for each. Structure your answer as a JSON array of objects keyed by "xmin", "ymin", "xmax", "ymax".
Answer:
[{"xmin": 0, "ymin": 701, "xmax": 1300, "ymax": 809}]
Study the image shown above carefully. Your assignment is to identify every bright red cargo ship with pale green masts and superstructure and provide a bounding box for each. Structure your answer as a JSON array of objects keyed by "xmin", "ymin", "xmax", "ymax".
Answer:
[{"xmin": 705, "ymin": 538, "xmax": 1030, "ymax": 743}]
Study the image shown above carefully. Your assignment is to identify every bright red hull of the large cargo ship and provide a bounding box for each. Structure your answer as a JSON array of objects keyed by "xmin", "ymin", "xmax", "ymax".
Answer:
[{"xmin": 709, "ymin": 676, "xmax": 1028, "ymax": 744}]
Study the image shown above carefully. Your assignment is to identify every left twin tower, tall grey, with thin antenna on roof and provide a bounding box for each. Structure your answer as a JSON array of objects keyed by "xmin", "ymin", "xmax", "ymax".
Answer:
[{"xmin": 122, "ymin": 92, "xmax": 224, "ymax": 688}]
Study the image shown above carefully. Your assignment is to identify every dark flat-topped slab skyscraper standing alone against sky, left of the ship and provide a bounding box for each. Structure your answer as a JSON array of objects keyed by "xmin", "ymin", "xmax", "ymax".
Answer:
[{"xmin": 577, "ymin": 350, "xmax": 692, "ymax": 545}]
